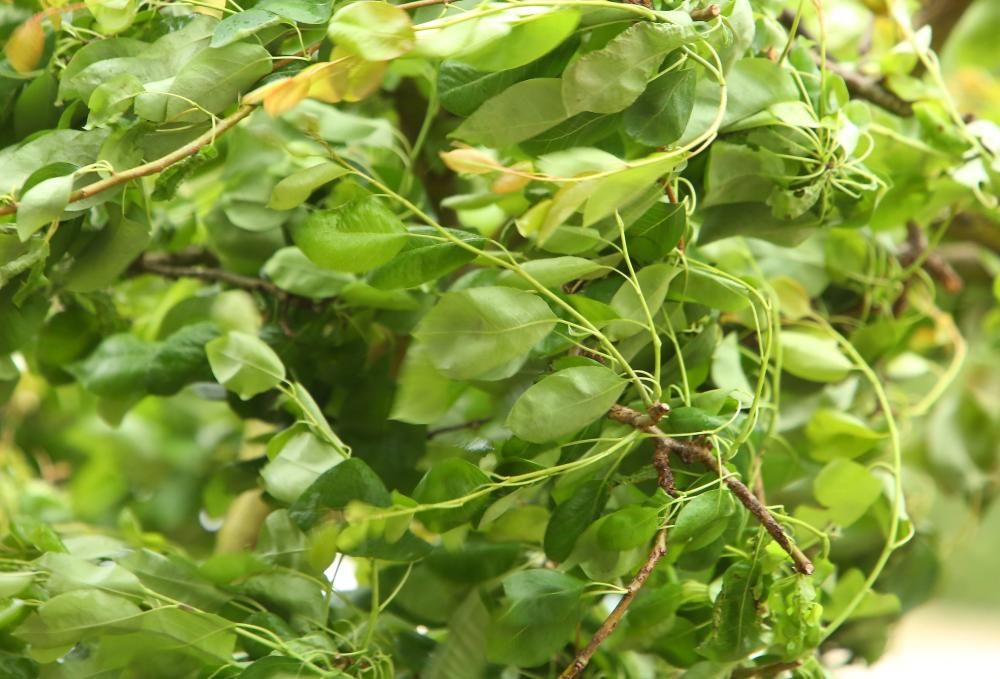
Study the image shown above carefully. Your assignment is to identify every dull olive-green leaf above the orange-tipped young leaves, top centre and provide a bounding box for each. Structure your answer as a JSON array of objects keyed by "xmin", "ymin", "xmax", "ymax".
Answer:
[{"xmin": 452, "ymin": 78, "xmax": 569, "ymax": 148}]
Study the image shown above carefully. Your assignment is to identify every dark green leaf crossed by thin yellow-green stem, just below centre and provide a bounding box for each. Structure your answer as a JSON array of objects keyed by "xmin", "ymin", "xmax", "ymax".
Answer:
[{"xmin": 413, "ymin": 457, "xmax": 490, "ymax": 533}]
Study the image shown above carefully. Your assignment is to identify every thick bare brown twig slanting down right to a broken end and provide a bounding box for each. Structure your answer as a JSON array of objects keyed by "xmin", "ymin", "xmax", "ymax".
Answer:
[{"xmin": 608, "ymin": 405, "xmax": 813, "ymax": 575}]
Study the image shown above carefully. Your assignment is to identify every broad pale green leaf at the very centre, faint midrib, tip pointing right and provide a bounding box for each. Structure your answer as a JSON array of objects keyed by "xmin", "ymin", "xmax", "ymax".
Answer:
[{"xmin": 414, "ymin": 287, "xmax": 556, "ymax": 380}]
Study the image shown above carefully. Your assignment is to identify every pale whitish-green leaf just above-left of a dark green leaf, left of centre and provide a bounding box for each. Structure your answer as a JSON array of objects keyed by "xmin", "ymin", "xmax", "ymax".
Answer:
[{"xmin": 260, "ymin": 425, "xmax": 346, "ymax": 503}]
